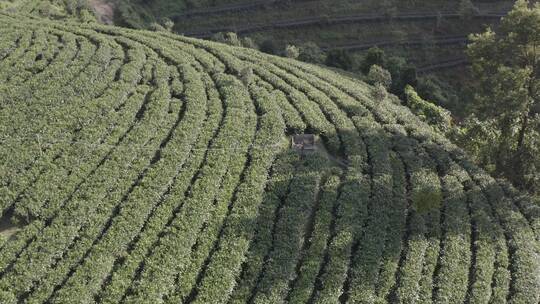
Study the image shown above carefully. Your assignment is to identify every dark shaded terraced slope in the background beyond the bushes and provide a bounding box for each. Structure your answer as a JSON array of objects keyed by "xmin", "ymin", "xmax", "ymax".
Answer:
[{"xmin": 113, "ymin": 0, "xmax": 514, "ymax": 66}]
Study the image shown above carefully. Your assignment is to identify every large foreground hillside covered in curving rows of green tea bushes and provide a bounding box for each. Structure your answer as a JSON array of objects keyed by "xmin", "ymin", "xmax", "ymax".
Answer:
[{"xmin": 0, "ymin": 11, "xmax": 540, "ymax": 304}]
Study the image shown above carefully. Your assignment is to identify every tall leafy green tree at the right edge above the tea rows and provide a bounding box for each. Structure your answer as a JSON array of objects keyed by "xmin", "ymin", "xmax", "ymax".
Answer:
[{"xmin": 467, "ymin": 0, "xmax": 540, "ymax": 191}]
